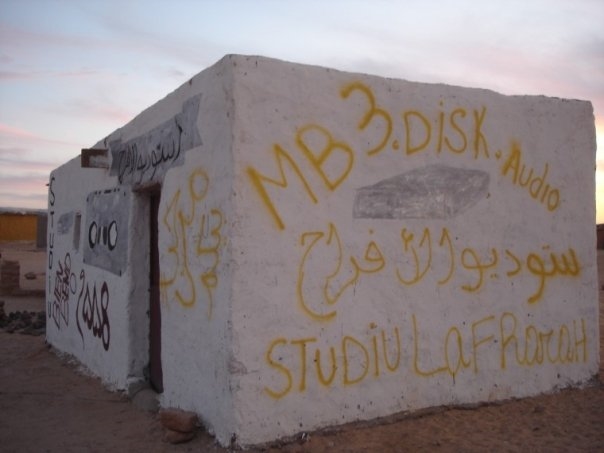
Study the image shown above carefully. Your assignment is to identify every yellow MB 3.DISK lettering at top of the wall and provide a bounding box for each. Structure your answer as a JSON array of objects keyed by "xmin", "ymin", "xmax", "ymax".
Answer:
[{"xmin": 246, "ymin": 81, "xmax": 490, "ymax": 230}]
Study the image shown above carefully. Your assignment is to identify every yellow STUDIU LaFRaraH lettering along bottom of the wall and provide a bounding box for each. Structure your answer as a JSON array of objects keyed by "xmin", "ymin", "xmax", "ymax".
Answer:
[{"xmin": 264, "ymin": 312, "xmax": 588, "ymax": 399}]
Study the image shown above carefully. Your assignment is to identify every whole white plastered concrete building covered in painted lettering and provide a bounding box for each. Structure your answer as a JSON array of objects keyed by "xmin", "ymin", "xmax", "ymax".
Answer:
[{"xmin": 47, "ymin": 56, "xmax": 599, "ymax": 445}]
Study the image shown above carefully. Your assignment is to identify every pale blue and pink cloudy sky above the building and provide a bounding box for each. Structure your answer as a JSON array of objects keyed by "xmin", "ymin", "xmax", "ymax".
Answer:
[{"xmin": 0, "ymin": 0, "xmax": 604, "ymax": 219}]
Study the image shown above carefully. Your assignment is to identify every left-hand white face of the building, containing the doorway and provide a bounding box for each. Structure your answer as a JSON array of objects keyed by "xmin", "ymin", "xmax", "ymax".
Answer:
[{"xmin": 47, "ymin": 54, "xmax": 237, "ymax": 442}]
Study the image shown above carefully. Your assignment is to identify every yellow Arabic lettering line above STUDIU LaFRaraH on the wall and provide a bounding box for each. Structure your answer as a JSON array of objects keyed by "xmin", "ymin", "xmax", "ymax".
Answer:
[{"xmin": 296, "ymin": 223, "xmax": 581, "ymax": 321}]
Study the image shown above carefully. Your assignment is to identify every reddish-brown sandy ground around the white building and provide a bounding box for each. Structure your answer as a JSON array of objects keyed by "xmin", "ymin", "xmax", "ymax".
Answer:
[{"xmin": 0, "ymin": 240, "xmax": 604, "ymax": 453}]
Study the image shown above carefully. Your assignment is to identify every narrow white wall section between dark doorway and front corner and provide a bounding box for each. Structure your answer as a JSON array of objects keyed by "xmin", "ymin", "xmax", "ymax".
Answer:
[{"xmin": 153, "ymin": 61, "xmax": 236, "ymax": 436}]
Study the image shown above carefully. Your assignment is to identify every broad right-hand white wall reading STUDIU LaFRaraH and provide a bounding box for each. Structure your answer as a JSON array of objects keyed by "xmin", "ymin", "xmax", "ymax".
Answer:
[{"xmin": 232, "ymin": 54, "xmax": 598, "ymax": 444}]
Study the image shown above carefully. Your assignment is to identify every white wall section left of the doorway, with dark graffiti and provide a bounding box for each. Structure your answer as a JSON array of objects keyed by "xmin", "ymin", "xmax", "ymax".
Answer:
[{"xmin": 46, "ymin": 158, "xmax": 132, "ymax": 388}]
